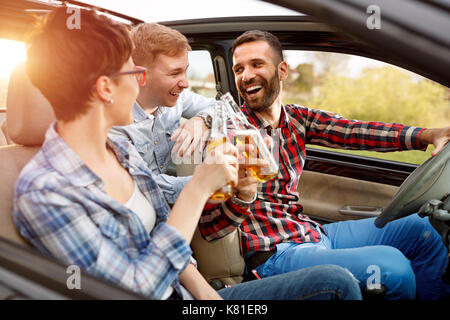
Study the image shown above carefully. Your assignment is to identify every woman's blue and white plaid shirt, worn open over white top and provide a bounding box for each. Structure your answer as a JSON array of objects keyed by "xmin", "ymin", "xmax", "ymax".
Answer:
[{"xmin": 13, "ymin": 124, "xmax": 213, "ymax": 299}]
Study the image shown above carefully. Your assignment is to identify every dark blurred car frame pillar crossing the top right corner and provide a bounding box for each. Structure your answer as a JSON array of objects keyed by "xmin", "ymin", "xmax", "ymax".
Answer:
[{"xmin": 263, "ymin": 0, "xmax": 450, "ymax": 87}]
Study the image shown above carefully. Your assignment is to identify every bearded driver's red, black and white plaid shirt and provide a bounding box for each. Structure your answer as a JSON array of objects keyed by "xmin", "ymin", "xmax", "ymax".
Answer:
[{"xmin": 200, "ymin": 105, "xmax": 423, "ymax": 253}]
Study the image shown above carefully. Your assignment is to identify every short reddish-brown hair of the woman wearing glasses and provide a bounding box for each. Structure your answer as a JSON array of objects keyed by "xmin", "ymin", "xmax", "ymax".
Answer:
[{"xmin": 27, "ymin": 7, "xmax": 133, "ymax": 121}]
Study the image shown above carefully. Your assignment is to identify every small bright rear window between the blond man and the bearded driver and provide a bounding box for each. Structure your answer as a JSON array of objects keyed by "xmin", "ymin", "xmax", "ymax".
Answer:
[{"xmin": 187, "ymin": 50, "xmax": 217, "ymax": 98}]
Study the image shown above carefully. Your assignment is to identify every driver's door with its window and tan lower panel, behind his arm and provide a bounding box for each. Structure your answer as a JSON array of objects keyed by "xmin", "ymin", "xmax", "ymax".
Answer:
[{"xmin": 283, "ymin": 42, "xmax": 450, "ymax": 222}]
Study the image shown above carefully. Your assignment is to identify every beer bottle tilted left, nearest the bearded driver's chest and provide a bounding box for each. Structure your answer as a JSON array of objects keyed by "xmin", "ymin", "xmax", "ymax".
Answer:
[{"xmin": 220, "ymin": 92, "xmax": 279, "ymax": 182}]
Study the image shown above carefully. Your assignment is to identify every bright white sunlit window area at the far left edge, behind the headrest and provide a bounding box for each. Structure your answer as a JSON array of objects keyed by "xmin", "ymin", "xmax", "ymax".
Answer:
[{"xmin": 0, "ymin": 39, "xmax": 26, "ymax": 112}]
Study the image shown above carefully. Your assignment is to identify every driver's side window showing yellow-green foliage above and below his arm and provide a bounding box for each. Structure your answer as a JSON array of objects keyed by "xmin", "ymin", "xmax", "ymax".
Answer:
[{"xmin": 283, "ymin": 50, "xmax": 450, "ymax": 164}]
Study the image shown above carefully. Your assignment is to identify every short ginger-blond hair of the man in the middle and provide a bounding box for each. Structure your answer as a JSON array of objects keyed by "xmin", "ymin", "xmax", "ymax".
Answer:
[{"xmin": 131, "ymin": 23, "xmax": 191, "ymax": 67}]
